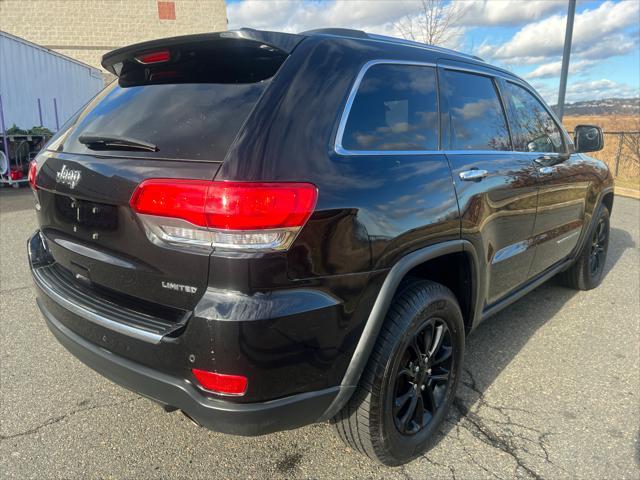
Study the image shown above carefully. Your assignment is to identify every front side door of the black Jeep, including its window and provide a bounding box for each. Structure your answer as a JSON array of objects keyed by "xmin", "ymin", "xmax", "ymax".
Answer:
[{"xmin": 503, "ymin": 80, "xmax": 589, "ymax": 276}]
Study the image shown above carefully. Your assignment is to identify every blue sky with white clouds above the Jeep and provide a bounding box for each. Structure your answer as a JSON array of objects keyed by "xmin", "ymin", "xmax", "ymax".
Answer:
[{"xmin": 227, "ymin": 0, "xmax": 640, "ymax": 104}]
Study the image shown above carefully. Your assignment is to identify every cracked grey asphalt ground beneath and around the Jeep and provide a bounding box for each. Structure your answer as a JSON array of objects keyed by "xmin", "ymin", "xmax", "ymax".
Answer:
[{"xmin": 0, "ymin": 188, "xmax": 640, "ymax": 479}]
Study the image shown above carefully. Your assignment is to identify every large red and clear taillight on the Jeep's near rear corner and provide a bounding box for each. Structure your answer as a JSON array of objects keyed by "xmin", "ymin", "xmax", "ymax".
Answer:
[{"xmin": 130, "ymin": 179, "xmax": 318, "ymax": 251}]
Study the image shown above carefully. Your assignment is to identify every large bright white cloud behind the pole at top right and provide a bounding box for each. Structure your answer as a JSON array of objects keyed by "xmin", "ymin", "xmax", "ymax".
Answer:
[{"xmin": 478, "ymin": 1, "xmax": 640, "ymax": 64}]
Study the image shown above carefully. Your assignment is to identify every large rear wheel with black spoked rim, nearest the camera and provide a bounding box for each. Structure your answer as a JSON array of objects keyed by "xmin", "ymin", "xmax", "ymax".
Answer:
[{"xmin": 332, "ymin": 280, "xmax": 465, "ymax": 466}]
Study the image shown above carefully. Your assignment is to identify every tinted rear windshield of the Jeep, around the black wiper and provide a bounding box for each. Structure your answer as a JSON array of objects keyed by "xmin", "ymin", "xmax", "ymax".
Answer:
[{"xmin": 56, "ymin": 80, "xmax": 269, "ymax": 161}]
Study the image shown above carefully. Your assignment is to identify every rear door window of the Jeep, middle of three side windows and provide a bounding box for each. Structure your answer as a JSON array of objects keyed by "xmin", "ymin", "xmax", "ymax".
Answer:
[{"xmin": 443, "ymin": 70, "xmax": 511, "ymax": 150}]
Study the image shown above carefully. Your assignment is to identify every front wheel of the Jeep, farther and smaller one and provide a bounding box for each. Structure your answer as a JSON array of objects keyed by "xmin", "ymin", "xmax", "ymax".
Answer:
[{"xmin": 559, "ymin": 205, "xmax": 610, "ymax": 290}]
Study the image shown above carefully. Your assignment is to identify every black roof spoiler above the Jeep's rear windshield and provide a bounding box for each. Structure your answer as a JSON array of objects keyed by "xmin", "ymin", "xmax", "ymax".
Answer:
[{"xmin": 101, "ymin": 28, "xmax": 304, "ymax": 77}]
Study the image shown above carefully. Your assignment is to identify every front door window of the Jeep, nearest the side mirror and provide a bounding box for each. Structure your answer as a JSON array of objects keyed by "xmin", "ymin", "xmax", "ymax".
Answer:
[{"xmin": 506, "ymin": 82, "xmax": 563, "ymax": 152}]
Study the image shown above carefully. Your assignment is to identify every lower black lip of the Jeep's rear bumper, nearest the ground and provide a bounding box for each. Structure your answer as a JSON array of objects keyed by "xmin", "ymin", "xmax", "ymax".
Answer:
[{"xmin": 38, "ymin": 299, "xmax": 339, "ymax": 435}]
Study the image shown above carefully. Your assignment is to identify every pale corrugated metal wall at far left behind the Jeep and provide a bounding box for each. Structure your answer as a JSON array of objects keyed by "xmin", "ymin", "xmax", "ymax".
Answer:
[{"xmin": 0, "ymin": 32, "xmax": 104, "ymax": 131}]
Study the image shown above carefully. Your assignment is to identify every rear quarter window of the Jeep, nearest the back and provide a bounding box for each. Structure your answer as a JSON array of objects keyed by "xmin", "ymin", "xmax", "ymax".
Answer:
[{"xmin": 342, "ymin": 64, "xmax": 438, "ymax": 150}]
